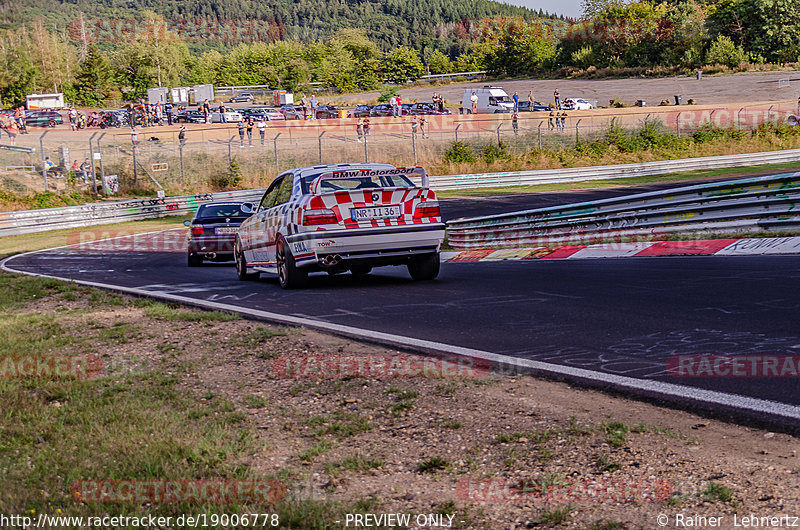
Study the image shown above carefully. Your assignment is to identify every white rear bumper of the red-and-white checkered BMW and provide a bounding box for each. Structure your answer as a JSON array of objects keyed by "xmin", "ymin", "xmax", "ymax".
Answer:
[{"xmin": 287, "ymin": 223, "xmax": 445, "ymax": 267}]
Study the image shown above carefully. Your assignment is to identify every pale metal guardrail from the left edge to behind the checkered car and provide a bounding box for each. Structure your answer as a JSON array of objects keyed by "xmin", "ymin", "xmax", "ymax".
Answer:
[{"xmin": 0, "ymin": 189, "xmax": 264, "ymax": 237}]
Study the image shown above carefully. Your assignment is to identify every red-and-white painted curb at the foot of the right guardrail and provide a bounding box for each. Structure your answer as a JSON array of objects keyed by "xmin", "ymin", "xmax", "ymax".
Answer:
[{"xmin": 442, "ymin": 237, "xmax": 800, "ymax": 263}]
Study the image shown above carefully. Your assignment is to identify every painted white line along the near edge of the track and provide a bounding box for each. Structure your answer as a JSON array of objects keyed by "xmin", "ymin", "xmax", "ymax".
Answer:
[{"xmin": 0, "ymin": 247, "xmax": 800, "ymax": 420}]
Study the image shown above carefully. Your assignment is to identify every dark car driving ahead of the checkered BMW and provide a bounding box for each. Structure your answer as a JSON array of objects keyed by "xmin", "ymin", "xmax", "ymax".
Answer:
[{"xmin": 183, "ymin": 202, "xmax": 253, "ymax": 267}]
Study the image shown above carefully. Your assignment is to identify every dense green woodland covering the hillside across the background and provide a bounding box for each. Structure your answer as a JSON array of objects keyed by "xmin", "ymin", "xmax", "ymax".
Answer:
[{"xmin": 0, "ymin": 0, "xmax": 800, "ymax": 106}]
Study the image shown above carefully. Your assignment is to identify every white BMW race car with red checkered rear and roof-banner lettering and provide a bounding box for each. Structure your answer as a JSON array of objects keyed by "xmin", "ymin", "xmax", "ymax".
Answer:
[{"xmin": 234, "ymin": 164, "xmax": 445, "ymax": 289}]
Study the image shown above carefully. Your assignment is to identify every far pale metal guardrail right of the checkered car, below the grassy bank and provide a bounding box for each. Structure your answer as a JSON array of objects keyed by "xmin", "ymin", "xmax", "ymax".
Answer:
[{"xmin": 430, "ymin": 149, "xmax": 800, "ymax": 191}]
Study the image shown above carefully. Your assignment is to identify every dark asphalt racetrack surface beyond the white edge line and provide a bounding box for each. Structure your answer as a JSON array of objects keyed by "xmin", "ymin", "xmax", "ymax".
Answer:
[{"xmin": 8, "ymin": 188, "xmax": 800, "ymax": 412}]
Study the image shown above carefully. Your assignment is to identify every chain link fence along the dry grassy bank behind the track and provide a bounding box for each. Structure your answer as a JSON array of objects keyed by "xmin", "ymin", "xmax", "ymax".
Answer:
[{"xmin": 0, "ymin": 100, "xmax": 797, "ymax": 193}]
